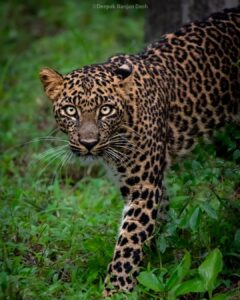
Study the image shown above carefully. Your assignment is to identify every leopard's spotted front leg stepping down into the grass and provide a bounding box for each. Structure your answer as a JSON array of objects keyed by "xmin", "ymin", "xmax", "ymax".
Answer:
[{"xmin": 104, "ymin": 184, "xmax": 161, "ymax": 296}]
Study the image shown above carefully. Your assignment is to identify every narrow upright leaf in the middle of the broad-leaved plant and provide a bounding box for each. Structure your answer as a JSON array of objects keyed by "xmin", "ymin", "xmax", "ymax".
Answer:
[{"xmin": 166, "ymin": 252, "xmax": 191, "ymax": 291}]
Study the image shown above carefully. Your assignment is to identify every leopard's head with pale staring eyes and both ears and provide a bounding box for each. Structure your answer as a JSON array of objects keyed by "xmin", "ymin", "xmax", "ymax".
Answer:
[{"xmin": 40, "ymin": 64, "xmax": 132, "ymax": 160}]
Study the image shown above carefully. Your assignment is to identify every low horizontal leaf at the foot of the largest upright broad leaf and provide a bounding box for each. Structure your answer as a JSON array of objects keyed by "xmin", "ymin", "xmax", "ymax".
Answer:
[{"xmin": 175, "ymin": 278, "xmax": 206, "ymax": 297}]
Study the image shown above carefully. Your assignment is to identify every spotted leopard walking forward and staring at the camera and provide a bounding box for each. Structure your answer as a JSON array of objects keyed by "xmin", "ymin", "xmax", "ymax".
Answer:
[{"xmin": 40, "ymin": 7, "xmax": 240, "ymax": 297}]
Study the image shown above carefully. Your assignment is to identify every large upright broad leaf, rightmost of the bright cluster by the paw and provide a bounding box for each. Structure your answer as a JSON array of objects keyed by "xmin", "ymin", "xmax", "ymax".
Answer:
[{"xmin": 198, "ymin": 249, "xmax": 222, "ymax": 291}]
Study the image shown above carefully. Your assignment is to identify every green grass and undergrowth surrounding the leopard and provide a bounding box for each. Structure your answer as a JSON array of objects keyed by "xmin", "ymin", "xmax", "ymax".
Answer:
[{"xmin": 0, "ymin": 1, "xmax": 240, "ymax": 300}]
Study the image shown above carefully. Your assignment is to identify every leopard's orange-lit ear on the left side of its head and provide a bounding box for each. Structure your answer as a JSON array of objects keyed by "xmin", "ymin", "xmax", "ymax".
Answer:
[{"xmin": 40, "ymin": 68, "xmax": 63, "ymax": 101}]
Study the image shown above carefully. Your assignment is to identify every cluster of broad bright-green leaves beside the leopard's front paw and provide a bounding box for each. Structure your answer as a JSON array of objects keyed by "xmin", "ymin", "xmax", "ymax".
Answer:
[{"xmin": 138, "ymin": 249, "xmax": 226, "ymax": 300}]
